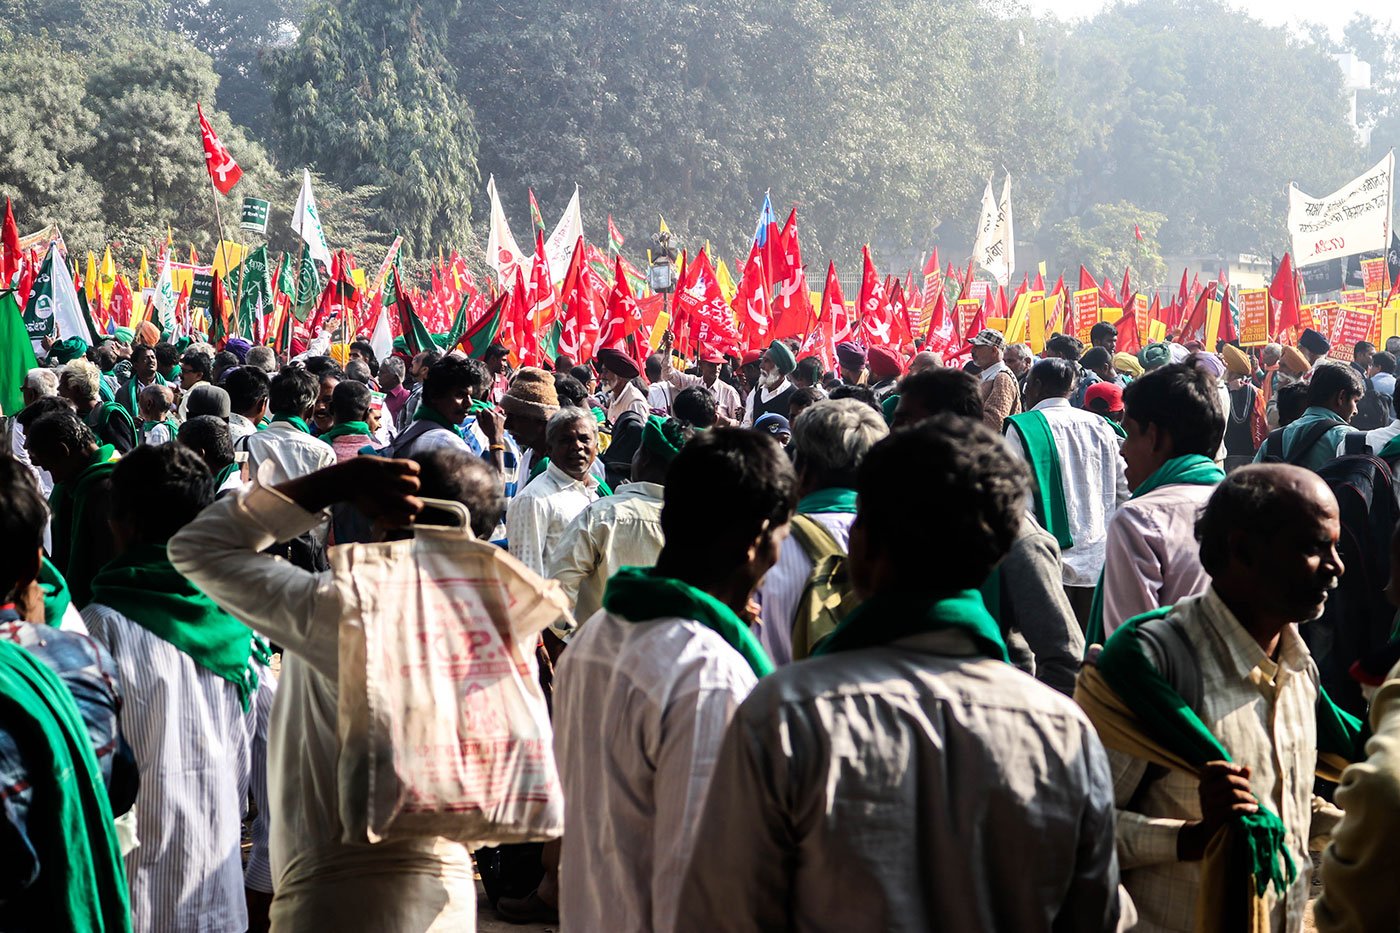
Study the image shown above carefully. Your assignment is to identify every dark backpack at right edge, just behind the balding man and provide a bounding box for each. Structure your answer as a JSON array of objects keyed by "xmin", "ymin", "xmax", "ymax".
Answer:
[{"xmin": 1298, "ymin": 454, "xmax": 1400, "ymax": 719}]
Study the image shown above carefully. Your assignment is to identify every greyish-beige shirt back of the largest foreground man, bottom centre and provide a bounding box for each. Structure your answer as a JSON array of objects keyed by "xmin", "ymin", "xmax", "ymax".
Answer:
[{"xmin": 672, "ymin": 632, "xmax": 1134, "ymax": 933}]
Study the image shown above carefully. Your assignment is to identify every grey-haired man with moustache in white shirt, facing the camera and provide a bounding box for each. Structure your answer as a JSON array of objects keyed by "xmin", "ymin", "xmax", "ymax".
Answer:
[{"xmin": 505, "ymin": 408, "xmax": 608, "ymax": 574}]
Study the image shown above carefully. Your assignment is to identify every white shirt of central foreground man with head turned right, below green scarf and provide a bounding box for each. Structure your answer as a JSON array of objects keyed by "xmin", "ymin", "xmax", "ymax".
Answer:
[{"xmin": 554, "ymin": 611, "xmax": 756, "ymax": 933}]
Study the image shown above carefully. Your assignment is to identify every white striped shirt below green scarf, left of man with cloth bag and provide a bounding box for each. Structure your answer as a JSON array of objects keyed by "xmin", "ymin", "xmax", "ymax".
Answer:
[{"xmin": 83, "ymin": 604, "xmax": 276, "ymax": 933}]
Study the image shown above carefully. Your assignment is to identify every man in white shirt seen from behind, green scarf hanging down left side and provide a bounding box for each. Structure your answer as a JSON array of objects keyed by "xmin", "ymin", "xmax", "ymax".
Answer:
[{"xmin": 1007, "ymin": 359, "xmax": 1128, "ymax": 623}]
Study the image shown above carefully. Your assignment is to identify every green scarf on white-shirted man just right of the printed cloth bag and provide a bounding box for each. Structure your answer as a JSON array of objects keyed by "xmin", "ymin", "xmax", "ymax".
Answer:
[{"xmin": 603, "ymin": 567, "xmax": 773, "ymax": 677}]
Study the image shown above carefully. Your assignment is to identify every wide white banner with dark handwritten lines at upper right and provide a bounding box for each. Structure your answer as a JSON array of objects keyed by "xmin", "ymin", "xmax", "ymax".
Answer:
[{"xmin": 1288, "ymin": 150, "xmax": 1396, "ymax": 266}]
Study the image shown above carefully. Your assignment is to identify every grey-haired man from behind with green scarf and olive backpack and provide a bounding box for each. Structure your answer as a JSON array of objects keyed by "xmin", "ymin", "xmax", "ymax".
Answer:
[{"xmin": 759, "ymin": 398, "xmax": 889, "ymax": 665}]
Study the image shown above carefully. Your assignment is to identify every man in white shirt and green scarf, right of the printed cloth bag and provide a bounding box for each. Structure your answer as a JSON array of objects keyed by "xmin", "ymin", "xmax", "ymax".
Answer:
[{"xmin": 554, "ymin": 427, "xmax": 797, "ymax": 933}]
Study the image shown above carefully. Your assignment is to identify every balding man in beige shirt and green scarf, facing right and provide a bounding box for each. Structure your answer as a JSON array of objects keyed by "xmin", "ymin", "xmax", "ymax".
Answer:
[{"xmin": 1097, "ymin": 465, "xmax": 1344, "ymax": 933}]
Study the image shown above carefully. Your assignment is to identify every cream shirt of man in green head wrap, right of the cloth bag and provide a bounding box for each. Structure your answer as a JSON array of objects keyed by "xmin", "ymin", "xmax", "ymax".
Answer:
[{"xmin": 545, "ymin": 483, "xmax": 664, "ymax": 621}]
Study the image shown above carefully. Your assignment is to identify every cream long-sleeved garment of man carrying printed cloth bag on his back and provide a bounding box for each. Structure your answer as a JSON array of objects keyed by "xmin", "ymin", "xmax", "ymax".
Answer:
[{"xmin": 169, "ymin": 487, "xmax": 476, "ymax": 933}]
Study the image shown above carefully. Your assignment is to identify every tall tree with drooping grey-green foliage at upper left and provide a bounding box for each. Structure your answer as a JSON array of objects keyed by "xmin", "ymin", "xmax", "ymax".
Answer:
[{"xmin": 269, "ymin": 0, "xmax": 477, "ymax": 252}]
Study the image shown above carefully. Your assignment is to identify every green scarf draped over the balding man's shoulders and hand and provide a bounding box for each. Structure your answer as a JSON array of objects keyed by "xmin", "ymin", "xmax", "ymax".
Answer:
[{"xmin": 1098, "ymin": 607, "xmax": 1364, "ymax": 897}]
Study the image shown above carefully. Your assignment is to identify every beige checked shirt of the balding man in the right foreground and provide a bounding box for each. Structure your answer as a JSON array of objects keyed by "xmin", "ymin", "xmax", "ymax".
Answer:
[{"xmin": 1109, "ymin": 588, "xmax": 1319, "ymax": 933}]
